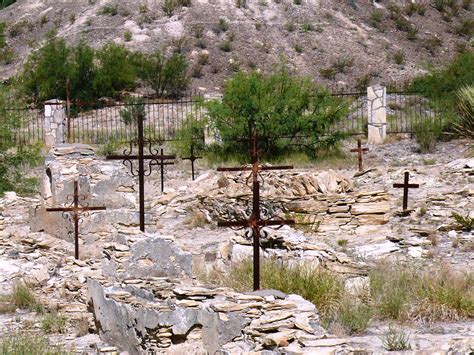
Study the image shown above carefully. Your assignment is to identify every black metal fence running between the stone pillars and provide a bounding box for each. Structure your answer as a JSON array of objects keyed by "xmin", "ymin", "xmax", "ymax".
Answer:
[{"xmin": 7, "ymin": 85, "xmax": 448, "ymax": 144}]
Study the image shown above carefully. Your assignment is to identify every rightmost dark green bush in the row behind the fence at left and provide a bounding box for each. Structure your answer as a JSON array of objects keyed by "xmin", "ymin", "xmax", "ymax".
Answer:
[{"xmin": 140, "ymin": 51, "xmax": 189, "ymax": 97}]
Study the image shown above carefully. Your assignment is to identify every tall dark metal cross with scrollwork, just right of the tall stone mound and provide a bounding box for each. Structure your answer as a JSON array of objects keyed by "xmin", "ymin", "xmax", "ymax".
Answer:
[{"xmin": 106, "ymin": 113, "xmax": 176, "ymax": 232}]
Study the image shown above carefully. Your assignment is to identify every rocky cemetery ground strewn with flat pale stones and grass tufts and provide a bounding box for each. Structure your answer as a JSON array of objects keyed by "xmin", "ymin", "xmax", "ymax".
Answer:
[{"xmin": 0, "ymin": 136, "xmax": 474, "ymax": 354}]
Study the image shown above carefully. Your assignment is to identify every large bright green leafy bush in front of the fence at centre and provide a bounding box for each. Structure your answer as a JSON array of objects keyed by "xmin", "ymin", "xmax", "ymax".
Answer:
[{"xmin": 205, "ymin": 69, "xmax": 349, "ymax": 158}]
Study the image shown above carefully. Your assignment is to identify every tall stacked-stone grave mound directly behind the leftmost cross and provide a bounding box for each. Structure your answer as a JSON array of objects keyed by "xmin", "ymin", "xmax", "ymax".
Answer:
[{"xmin": 30, "ymin": 144, "xmax": 138, "ymax": 248}]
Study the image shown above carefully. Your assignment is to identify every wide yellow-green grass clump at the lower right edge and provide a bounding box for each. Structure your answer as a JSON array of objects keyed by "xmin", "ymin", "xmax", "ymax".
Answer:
[{"xmin": 369, "ymin": 264, "xmax": 474, "ymax": 322}]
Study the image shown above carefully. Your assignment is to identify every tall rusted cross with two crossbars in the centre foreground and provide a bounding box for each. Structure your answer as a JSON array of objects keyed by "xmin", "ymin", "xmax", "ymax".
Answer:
[{"xmin": 217, "ymin": 129, "xmax": 295, "ymax": 290}]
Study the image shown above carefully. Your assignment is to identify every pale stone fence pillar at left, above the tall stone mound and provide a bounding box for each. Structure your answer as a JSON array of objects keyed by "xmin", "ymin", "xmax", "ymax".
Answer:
[{"xmin": 44, "ymin": 99, "xmax": 66, "ymax": 148}]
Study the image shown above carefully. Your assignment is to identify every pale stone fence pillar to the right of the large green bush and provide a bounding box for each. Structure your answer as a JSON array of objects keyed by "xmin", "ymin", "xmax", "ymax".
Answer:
[{"xmin": 367, "ymin": 85, "xmax": 387, "ymax": 144}]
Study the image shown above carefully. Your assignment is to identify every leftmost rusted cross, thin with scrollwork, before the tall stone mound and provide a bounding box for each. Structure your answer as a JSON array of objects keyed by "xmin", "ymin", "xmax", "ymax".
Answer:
[{"xmin": 46, "ymin": 180, "xmax": 106, "ymax": 259}]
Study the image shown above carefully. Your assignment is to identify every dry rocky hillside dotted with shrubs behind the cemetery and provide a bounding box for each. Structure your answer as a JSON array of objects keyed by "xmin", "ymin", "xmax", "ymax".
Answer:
[{"xmin": 0, "ymin": 0, "xmax": 474, "ymax": 91}]
